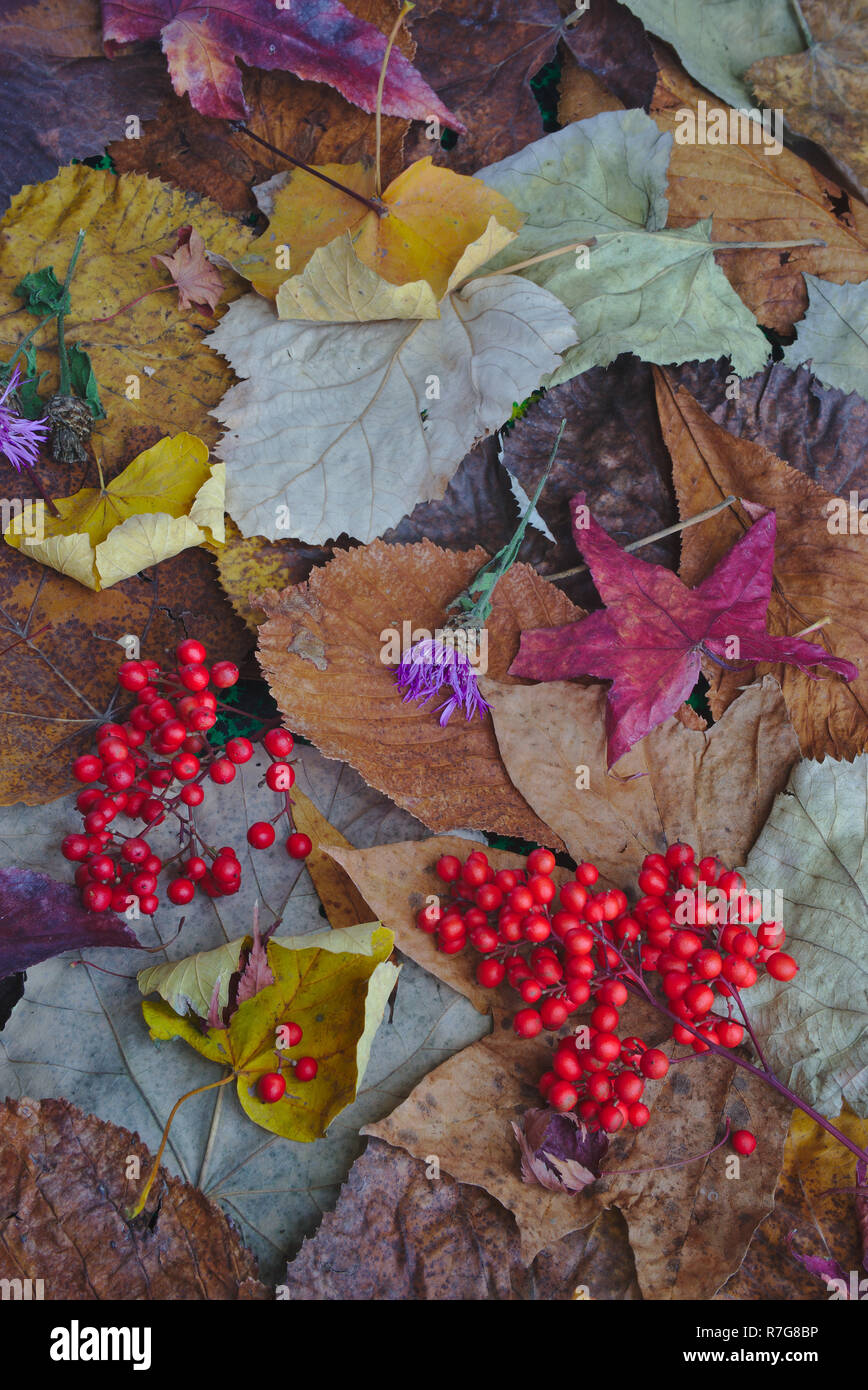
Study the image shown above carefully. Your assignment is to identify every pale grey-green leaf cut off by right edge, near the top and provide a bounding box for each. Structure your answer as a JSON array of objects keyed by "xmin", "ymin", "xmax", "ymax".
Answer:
[{"xmin": 783, "ymin": 275, "xmax": 868, "ymax": 399}]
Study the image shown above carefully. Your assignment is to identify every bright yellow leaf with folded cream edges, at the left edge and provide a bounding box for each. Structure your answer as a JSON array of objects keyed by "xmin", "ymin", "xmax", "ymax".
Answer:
[{"xmin": 4, "ymin": 434, "xmax": 225, "ymax": 591}]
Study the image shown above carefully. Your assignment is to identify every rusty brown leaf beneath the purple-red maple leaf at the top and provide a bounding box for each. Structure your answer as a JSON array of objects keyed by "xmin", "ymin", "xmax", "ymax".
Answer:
[{"xmin": 109, "ymin": 0, "xmax": 411, "ymax": 214}]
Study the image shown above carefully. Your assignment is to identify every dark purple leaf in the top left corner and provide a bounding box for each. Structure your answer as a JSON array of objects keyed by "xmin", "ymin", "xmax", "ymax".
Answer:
[{"xmin": 0, "ymin": 0, "xmax": 168, "ymax": 207}]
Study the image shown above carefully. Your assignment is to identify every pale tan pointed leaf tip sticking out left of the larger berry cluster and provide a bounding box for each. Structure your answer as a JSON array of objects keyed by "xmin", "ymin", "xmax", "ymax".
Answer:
[{"xmin": 328, "ymin": 835, "xmax": 569, "ymax": 1013}]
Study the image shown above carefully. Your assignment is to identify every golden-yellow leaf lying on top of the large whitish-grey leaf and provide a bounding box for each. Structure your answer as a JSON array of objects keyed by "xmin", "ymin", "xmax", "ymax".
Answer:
[{"xmin": 235, "ymin": 157, "xmax": 524, "ymax": 317}]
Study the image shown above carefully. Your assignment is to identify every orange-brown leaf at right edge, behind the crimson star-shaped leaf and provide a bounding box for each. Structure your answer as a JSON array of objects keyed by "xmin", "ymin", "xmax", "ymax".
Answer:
[{"xmin": 655, "ymin": 371, "xmax": 868, "ymax": 760}]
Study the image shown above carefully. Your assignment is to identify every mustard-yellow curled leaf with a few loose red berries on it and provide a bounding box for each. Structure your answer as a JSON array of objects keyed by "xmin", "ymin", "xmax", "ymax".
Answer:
[{"xmin": 139, "ymin": 926, "xmax": 398, "ymax": 1143}]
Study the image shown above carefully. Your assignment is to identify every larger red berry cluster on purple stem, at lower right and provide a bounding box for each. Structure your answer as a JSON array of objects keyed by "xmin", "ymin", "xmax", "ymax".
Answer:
[{"xmin": 416, "ymin": 844, "xmax": 798, "ymax": 1154}]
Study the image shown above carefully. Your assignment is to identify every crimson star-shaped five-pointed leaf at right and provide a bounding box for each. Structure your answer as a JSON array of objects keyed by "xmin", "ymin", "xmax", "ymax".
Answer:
[{"xmin": 509, "ymin": 492, "xmax": 858, "ymax": 767}]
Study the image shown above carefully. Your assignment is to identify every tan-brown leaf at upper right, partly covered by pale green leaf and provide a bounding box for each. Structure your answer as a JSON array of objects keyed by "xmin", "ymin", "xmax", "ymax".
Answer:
[{"xmin": 651, "ymin": 49, "xmax": 868, "ymax": 334}]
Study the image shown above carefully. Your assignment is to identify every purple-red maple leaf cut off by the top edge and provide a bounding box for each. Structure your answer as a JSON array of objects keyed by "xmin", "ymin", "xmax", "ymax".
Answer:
[{"xmin": 103, "ymin": 0, "xmax": 465, "ymax": 131}]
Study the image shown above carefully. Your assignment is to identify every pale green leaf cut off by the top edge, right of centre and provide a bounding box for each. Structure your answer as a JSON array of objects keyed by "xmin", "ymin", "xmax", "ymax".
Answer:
[{"xmin": 625, "ymin": 0, "xmax": 804, "ymax": 107}]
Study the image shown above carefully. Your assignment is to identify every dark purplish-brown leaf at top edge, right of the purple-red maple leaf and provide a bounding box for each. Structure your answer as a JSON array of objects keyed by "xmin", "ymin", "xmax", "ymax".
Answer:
[{"xmin": 408, "ymin": 0, "xmax": 654, "ymax": 174}]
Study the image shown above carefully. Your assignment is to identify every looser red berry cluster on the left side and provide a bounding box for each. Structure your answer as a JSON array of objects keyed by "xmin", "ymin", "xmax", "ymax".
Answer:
[{"xmin": 61, "ymin": 639, "xmax": 312, "ymax": 916}]
